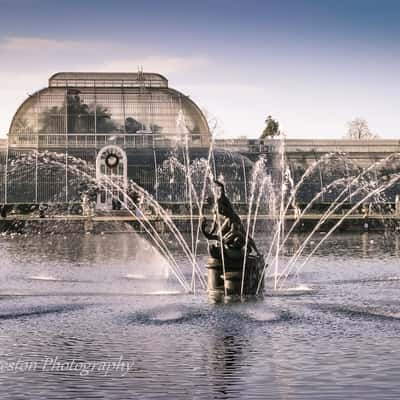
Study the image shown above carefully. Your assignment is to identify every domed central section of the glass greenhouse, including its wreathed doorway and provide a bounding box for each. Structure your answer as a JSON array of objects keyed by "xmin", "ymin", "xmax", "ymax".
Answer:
[{"xmin": 0, "ymin": 72, "xmax": 252, "ymax": 209}]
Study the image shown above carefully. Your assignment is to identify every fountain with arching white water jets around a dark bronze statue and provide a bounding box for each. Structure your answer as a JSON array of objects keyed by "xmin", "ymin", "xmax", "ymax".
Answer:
[{"xmin": 1, "ymin": 134, "xmax": 400, "ymax": 298}]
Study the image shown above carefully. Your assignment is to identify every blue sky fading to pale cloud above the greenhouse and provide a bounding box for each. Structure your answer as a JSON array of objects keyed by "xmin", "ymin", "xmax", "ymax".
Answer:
[{"xmin": 0, "ymin": 0, "xmax": 400, "ymax": 139}]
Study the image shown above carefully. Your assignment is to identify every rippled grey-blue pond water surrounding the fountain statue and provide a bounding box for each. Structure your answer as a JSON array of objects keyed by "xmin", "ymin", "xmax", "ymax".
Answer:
[{"xmin": 0, "ymin": 234, "xmax": 400, "ymax": 399}]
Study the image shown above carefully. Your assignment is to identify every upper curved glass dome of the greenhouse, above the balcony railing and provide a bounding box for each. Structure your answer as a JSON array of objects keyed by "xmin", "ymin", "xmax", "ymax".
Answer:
[{"xmin": 9, "ymin": 72, "xmax": 210, "ymax": 145}]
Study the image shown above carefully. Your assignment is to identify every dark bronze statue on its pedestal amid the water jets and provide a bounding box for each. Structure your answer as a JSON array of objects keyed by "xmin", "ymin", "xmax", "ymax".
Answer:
[{"xmin": 201, "ymin": 180, "xmax": 264, "ymax": 295}]
